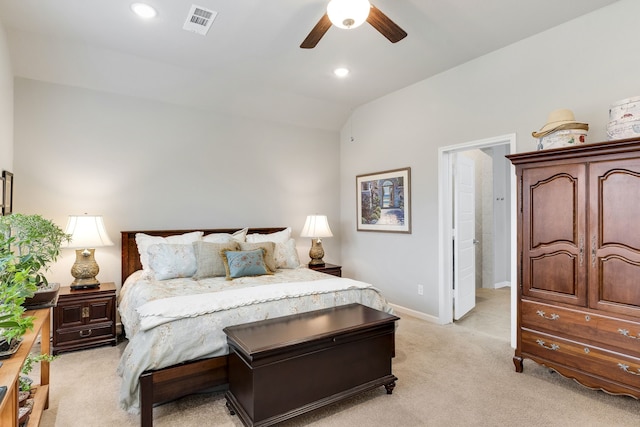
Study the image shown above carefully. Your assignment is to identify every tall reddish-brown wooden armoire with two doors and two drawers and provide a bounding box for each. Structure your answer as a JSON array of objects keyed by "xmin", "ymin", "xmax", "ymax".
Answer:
[{"xmin": 507, "ymin": 139, "xmax": 640, "ymax": 398}]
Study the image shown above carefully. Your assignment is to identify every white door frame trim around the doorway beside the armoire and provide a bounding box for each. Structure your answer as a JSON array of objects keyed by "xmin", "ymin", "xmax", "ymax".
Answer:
[{"xmin": 438, "ymin": 133, "xmax": 517, "ymax": 348}]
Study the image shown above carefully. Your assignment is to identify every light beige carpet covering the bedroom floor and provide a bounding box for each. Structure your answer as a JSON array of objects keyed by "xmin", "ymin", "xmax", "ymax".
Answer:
[{"xmin": 41, "ymin": 316, "xmax": 640, "ymax": 427}]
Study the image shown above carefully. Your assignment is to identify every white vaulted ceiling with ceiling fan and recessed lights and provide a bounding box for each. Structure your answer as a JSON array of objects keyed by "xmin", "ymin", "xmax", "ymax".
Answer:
[{"xmin": 0, "ymin": 0, "xmax": 615, "ymax": 130}]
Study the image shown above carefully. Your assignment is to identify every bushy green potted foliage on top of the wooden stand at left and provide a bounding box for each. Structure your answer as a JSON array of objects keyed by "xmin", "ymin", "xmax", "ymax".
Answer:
[{"xmin": 0, "ymin": 214, "xmax": 69, "ymax": 352}]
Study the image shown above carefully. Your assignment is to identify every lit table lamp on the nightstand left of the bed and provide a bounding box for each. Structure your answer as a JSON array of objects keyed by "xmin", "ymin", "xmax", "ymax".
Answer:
[{"xmin": 65, "ymin": 214, "xmax": 113, "ymax": 289}]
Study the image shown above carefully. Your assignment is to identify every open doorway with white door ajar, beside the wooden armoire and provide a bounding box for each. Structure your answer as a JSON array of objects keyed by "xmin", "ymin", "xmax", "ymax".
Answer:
[{"xmin": 438, "ymin": 134, "xmax": 516, "ymax": 345}]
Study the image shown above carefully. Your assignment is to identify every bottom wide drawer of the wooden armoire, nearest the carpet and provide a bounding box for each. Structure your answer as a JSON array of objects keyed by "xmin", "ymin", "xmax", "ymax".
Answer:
[{"xmin": 522, "ymin": 329, "xmax": 640, "ymax": 391}]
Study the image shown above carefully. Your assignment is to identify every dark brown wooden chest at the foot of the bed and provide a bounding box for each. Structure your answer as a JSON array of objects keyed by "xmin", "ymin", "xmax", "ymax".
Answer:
[{"xmin": 224, "ymin": 304, "xmax": 399, "ymax": 426}]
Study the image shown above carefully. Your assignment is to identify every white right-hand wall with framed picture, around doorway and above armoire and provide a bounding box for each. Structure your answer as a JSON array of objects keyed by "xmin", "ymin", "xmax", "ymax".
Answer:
[{"xmin": 340, "ymin": 0, "xmax": 640, "ymax": 317}]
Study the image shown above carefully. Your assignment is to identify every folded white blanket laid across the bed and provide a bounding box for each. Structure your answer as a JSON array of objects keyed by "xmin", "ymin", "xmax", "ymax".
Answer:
[{"xmin": 137, "ymin": 277, "xmax": 372, "ymax": 331}]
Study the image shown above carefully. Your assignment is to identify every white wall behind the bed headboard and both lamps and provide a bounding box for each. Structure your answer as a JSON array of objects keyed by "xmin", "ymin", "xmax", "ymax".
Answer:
[{"xmin": 14, "ymin": 78, "xmax": 340, "ymax": 285}]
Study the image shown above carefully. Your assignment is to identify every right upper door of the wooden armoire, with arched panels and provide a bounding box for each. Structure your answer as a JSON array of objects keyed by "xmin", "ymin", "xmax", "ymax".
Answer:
[{"xmin": 589, "ymin": 158, "xmax": 640, "ymax": 317}]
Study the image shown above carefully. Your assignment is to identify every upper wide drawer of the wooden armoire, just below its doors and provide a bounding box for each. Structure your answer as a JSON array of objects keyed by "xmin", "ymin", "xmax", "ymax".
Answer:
[{"xmin": 521, "ymin": 300, "xmax": 640, "ymax": 357}]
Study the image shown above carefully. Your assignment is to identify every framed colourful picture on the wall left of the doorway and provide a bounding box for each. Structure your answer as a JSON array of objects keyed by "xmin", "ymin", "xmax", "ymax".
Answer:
[{"xmin": 356, "ymin": 167, "xmax": 411, "ymax": 234}]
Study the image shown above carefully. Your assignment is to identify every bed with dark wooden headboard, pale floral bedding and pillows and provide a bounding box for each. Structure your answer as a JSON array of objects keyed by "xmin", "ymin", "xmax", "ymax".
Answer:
[{"xmin": 118, "ymin": 227, "xmax": 392, "ymax": 427}]
